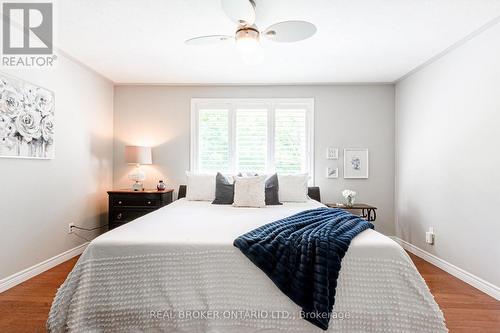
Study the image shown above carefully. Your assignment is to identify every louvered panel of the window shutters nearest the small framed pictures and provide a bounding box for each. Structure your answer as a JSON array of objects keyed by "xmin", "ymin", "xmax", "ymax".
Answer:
[{"xmin": 274, "ymin": 109, "xmax": 307, "ymax": 174}]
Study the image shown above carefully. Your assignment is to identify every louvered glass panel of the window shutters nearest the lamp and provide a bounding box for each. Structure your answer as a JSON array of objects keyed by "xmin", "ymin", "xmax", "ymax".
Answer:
[{"xmin": 198, "ymin": 109, "xmax": 230, "ymax": 172}]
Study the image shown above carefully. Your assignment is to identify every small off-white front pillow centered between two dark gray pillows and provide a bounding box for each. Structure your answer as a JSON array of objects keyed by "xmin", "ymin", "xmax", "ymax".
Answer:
[{"xmin": 233, "ymin": 176, "xmax": 266, "ymax": 207}]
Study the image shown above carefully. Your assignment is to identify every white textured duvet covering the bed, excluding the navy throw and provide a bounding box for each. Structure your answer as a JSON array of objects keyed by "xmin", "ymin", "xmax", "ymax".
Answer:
[{"xmin": 47, "ymin": 199, "xmax": 446, "ymax": 333}]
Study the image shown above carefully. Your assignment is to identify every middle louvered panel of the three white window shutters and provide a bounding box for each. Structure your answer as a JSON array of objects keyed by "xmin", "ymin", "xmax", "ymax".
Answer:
[{"xmin": 236, "ymin": 109, "xmax": 268, "ymax": 172}]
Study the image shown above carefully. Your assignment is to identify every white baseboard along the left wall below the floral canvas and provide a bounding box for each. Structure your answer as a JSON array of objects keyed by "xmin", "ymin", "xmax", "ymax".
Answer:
[{"xmin": 0, "ymin": 242, "xmax": 89, "ymax": 293}]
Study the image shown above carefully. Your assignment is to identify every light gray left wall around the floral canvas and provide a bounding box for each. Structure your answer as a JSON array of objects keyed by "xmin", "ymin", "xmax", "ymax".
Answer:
[{"xmin": 0, "ymin": 54, "xmax": 113, "ymax": 279}]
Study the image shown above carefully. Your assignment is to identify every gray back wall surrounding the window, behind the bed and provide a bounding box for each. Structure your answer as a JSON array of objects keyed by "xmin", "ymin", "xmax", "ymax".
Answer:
[{"xmin": 114, "ymin": 85, "xmax": 394, "ymax": 234}]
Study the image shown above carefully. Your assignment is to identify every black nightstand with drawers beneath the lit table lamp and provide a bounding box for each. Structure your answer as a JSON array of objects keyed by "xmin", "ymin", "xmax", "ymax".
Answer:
[{"xmin": 108, "ymin": 189, "xmax": 174, "ymax": 230}]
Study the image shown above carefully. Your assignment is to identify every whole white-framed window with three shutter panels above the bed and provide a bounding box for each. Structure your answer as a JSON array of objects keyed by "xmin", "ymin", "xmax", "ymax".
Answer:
[{"xmin": 191, "ymin": 98, "xmax": 314, "ymax": 176}]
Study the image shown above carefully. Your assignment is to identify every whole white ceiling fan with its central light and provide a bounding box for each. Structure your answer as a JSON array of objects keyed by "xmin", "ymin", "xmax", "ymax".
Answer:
[{"xmin": 185, "ymin": 0, "xmax": 316, "ymax": 58}]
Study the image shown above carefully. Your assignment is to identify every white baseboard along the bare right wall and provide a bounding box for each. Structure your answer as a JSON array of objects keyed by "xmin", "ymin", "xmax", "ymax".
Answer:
[{"xmin": 391, "ymin": 236, "xmax": 500, "ymax": 300}]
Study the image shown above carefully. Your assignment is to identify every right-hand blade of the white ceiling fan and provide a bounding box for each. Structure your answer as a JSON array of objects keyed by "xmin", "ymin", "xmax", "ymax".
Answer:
[{"xmin": 263, "ymin": 21, "xmax": 316, "ymax": 43}]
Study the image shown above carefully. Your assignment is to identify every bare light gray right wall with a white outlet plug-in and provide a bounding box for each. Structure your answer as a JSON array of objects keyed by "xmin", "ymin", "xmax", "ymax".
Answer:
[{"xmin": 396, "ymin": 24, "xmax": 500, "ymax": 286}]
